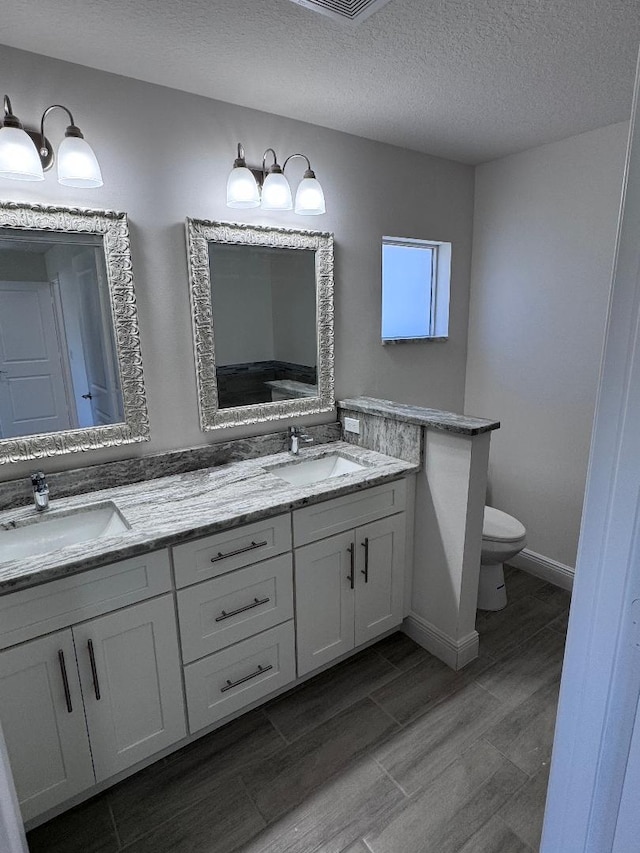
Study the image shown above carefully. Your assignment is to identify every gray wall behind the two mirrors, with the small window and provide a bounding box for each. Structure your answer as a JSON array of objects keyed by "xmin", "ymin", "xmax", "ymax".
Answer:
[{"xmin": 0, "ymin": 47, "xmax": 474, "ymax": 479}]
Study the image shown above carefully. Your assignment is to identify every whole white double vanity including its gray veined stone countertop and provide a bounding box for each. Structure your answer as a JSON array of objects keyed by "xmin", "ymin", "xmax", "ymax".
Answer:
[{"xmin": 0, "ymin": 442, "xmax": 418, "ymax": 821}]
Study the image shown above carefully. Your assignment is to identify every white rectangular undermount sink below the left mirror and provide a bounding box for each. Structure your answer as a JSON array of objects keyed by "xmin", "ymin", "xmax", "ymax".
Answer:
[{"xmin": 0, "ymin": 501, "xmax": 130, "ymax": 563}]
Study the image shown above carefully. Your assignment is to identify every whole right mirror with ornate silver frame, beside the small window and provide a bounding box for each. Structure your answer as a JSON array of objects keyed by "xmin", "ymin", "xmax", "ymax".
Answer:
[{"xmin": 186, "ymin": 219, "xmax": 334, "ymax": 430}]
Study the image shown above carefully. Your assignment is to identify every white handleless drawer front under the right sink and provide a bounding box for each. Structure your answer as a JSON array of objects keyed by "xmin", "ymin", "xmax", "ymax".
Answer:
[{"xmin": 293, "ymin": 480, "xmax": 406, "ymax": 547}]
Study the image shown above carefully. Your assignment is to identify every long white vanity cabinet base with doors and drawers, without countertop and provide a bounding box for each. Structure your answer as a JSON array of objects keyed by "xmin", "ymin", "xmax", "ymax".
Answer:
[{"xmin": 0, "ymin": 470, "xmax": 406, "ymax": 820}]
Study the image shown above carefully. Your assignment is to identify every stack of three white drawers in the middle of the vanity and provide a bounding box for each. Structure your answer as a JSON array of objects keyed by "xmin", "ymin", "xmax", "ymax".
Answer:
[{"xmin": 173, "ymin": 513, "xmax": 296, "ymax": 734}]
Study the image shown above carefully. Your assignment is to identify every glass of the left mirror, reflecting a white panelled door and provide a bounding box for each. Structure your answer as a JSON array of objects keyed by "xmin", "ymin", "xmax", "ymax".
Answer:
[{"xmin": 0, "ymin": 231, "xmax": 124, "ymax": 438}]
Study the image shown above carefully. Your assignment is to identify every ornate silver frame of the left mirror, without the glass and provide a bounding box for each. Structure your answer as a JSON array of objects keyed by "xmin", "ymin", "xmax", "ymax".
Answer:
[{"xmin": 0, "ymin": 201, "xmax": 149, "ymax": 464}]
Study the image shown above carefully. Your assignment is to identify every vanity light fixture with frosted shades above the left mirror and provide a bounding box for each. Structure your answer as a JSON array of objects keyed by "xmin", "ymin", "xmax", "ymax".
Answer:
[{"xmin": 0, "ymin": 95, "xmax": 103, "ymax": 187}]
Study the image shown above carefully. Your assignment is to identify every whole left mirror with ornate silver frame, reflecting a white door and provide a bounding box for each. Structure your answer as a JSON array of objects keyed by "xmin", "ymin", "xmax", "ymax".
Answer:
[{"xmin": 0, "ymin": 202, "xmax": 149, "ymax": 463}]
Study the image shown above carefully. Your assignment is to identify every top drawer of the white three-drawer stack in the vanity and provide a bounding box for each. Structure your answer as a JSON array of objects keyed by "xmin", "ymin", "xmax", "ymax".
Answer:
[{"xmin": 173, "ymin": 513, "xmax": 291, "ymax": 587}]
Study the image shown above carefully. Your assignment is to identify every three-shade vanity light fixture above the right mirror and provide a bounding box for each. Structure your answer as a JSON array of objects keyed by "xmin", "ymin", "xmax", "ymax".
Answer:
[{"xmin": 227, "ymin": 143, "xmax": 326, "ymax": 216}]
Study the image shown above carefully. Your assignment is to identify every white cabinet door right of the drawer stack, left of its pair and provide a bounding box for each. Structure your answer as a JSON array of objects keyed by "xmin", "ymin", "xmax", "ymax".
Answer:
[{"xmin": 295, "ymin": 531, "xmax": 356, "ymax": 675}]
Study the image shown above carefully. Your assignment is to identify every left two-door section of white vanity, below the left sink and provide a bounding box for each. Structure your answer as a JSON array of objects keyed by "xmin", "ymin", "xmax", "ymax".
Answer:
[{"xmin": 0, "ymin": 552, "xmax": 186, "ymax": 820}]
